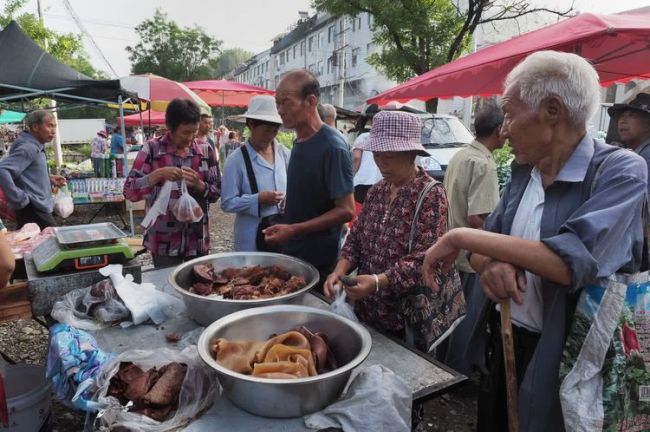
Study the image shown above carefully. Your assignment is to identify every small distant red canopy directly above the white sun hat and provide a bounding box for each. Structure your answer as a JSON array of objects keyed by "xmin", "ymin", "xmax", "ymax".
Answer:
[{"xmin": 183, "ymin": 80, "xmax": 275, "ymax": 107}]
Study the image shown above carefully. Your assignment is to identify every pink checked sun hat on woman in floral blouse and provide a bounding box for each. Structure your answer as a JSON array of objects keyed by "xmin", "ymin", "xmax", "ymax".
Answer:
[{"xmin": 363, "ymin": 111, "xmax": 429, "ymax": 156}]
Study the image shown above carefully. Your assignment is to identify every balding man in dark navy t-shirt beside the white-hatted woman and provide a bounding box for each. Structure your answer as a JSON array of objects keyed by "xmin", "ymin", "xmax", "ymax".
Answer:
[{"xmin": 264, "ymin": 70, "xmax": 354, "ymax": 285}]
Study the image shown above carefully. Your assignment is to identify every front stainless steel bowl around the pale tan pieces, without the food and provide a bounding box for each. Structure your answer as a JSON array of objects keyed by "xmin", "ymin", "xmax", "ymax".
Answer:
[{"xmin": 198, "ymin": 305, "xmax": 372, "ymax": 418}]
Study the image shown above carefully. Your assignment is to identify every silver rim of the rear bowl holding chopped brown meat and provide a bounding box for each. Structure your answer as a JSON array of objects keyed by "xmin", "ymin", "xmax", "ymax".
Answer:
[{"xmin": 169, "ymin": 252, "xmax": 320, "ymax": 307}]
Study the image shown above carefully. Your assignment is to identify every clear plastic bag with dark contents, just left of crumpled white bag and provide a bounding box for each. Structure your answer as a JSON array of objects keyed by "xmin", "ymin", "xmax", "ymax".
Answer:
[{"xmin": 51, "ymin": 279, "xmax": 131, "ymax": 331}]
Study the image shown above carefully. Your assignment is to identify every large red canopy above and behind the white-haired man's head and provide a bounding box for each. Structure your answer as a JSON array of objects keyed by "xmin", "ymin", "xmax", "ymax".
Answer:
[{"xmin": 368, "ymin": 13, "xmax": 650, "ymax": 105}]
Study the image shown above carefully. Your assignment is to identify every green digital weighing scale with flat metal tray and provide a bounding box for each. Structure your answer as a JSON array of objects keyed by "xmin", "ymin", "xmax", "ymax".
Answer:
[{"xmin": 32, "ymin": 222, "xmax": 134, "ymax": 273}]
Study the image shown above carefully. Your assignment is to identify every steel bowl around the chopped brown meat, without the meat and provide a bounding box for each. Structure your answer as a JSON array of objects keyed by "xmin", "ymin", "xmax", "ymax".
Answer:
[{"xmin": 169, "ymin": 252, "xmax": 319, "ymax": 326}]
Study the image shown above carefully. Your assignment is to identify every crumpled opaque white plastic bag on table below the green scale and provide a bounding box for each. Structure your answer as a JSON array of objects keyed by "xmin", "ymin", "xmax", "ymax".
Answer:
[{"xmin": 99, "ymin": 264, "xmax": 181, "ymax": 326}]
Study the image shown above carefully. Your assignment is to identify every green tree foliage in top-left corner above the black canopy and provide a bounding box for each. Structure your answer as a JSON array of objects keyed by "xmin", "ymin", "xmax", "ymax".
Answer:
[{"xmin": 0, "ymin": 0, "xmax": 106, "ymax": 79}]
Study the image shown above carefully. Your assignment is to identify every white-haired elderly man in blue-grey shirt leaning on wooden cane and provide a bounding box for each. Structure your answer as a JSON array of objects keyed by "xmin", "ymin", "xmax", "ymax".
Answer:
[{"xmin": 423, "ymin": 51, "xmax": 647, "ymax": 431}]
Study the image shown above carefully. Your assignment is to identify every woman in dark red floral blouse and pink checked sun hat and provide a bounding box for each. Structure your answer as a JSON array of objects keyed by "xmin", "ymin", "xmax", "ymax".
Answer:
[{"xmin": 325, "ymin": 111, "xmax": 465, "ymax": 351}]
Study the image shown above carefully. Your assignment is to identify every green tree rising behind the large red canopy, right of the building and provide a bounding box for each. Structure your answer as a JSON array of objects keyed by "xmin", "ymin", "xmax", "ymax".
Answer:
[{"xmin": 312, "ymin": 0, "xmax": 573, "ymax": 110}]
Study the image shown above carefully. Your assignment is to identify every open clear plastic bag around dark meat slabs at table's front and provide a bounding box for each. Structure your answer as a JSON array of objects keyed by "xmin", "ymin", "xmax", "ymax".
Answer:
[{"xmin": 86, "ymin": 346, "xmax": 219, "ymax": 432}]
